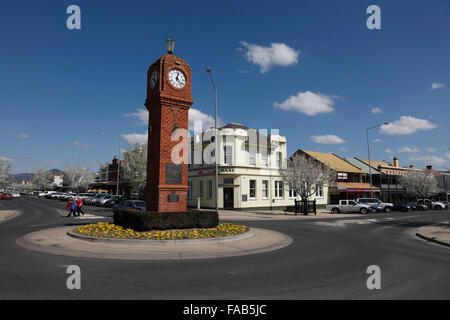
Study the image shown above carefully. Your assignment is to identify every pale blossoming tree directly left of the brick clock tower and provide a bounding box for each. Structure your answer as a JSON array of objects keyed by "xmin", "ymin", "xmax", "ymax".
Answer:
[{"xmin": 123, "ymin": 143, "xmax": 147, "ymax": 199}]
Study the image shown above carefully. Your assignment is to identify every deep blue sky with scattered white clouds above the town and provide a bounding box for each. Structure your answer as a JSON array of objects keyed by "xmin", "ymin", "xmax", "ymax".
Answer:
[{"xmin": 0, "ymin": 0, "xmax": 450, "ymax": 172}]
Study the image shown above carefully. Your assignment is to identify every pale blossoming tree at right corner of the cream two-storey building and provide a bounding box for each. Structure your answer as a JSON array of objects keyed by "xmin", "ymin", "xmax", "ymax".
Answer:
[{"xmin": 280, "ymin": 153, "xmax": 336, "ymax": 200}]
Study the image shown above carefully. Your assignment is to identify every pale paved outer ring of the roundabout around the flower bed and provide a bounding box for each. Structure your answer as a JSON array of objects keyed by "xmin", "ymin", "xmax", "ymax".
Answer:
[{"xmin": 16, "ymin": 226, "xmax": 293, "ymax": 260}]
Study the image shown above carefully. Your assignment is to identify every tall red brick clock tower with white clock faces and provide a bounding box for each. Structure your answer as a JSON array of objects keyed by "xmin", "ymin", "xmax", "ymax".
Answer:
[{"xmin": 145, "ymin": 39, "xmax": 193, "ymax": 212}]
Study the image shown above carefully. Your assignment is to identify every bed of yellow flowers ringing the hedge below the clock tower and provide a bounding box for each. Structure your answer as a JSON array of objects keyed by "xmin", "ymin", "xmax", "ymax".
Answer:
[{"xmin": 74, "ymin": 222, "xmax": 249, "ymax": 240}]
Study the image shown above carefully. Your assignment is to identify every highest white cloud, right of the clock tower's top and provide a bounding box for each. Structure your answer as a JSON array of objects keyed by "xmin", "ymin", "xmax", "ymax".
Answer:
[{"xmin": 241, "ymin": 41, "xmax": 300, "ymax": 73}]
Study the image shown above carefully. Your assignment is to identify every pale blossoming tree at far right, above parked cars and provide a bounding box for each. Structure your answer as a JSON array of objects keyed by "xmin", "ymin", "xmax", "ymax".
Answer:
[{"xmin": 400, "ymin": 171, "xmax": 441, "ymax": 198}]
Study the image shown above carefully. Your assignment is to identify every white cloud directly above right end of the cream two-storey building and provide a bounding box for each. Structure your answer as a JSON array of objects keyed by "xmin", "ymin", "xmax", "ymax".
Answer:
[{"xmin": 274, "ymin": 91, "xmax": 339, "ymax": 116}]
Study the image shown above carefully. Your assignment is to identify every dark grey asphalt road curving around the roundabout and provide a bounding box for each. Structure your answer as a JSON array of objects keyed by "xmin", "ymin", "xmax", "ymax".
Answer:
[{"xmin": 0, "ymin": 198, "xmax": 450, "ymax": 299}]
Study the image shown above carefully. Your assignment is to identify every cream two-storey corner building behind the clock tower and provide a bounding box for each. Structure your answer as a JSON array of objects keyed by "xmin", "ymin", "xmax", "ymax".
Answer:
[{"xmin": 188, "ymin": 123, "xmax": 326, "ymax": 210}]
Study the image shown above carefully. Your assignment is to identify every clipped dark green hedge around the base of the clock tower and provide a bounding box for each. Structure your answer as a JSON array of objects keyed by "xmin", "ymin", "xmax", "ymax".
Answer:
[{"xmin": 114, "ymin": 209, "xmax": 219, "ymax": 231}]
